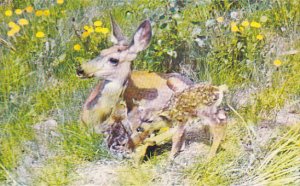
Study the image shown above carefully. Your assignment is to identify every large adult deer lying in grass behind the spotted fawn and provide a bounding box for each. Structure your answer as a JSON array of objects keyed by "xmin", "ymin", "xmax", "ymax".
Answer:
[{"xmin": 77, "ymin": 17, "xmax": 192, "ymax": 130}]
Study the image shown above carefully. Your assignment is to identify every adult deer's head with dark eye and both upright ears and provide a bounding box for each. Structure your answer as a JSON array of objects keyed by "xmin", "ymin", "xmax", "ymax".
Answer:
[{"xmin": 77, "ymin": 16, "xmax": 152, "ymax": 81}]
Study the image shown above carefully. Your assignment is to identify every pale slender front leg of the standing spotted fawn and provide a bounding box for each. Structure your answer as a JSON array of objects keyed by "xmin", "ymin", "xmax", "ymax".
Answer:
[{"xmin": 169, "ymin": 125, "xmax": 185, "ymax": 160}]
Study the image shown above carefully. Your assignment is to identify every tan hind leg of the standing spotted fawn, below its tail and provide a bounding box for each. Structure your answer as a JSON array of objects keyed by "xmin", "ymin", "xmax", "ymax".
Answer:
[{"xmin": 208, "ymin": 123, "xmax": 227, "ymax": 159}]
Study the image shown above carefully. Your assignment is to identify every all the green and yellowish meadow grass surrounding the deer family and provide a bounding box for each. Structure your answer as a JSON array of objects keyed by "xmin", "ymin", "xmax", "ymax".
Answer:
[{"xmin": 0, "ymin": 0, "xmax": 300, "ymax": 185}]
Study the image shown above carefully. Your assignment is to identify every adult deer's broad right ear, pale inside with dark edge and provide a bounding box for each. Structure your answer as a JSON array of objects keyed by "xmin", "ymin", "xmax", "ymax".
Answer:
[{"xmin": 129, "ymin": 20, "xmax": 152, "ymax": 53}]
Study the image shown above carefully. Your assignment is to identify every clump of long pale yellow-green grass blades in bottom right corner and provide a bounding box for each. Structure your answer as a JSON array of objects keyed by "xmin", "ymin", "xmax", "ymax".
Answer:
[{"xmin": 238, "ymin": 126, "xmax": 300, "ymax": 185}]
